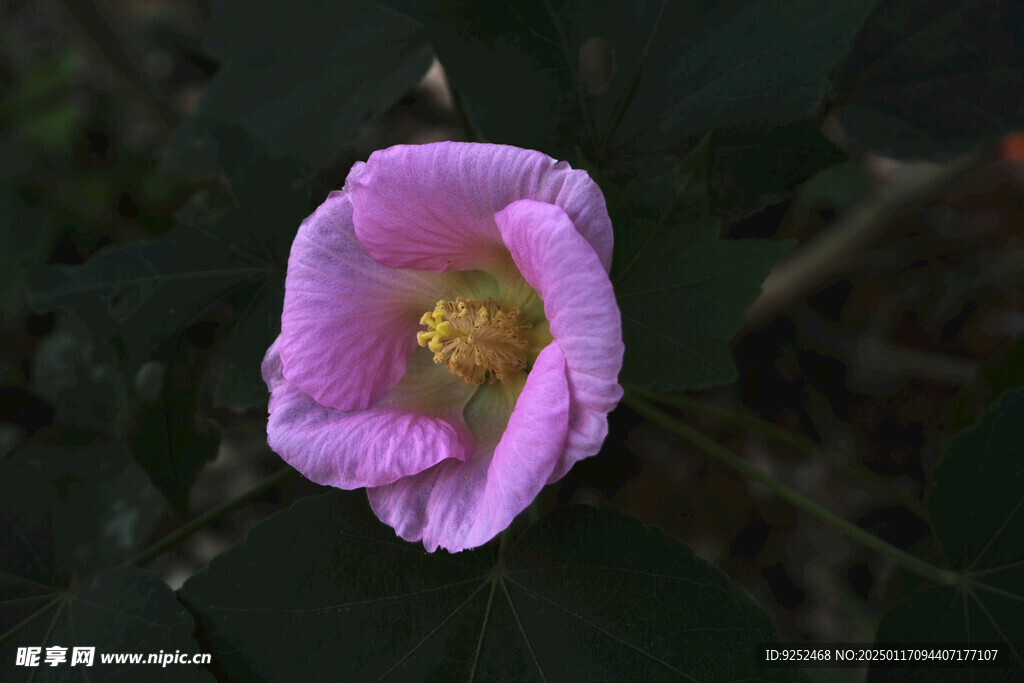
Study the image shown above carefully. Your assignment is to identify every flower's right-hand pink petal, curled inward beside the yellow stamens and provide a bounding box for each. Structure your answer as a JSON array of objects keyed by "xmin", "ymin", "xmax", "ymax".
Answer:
[{"xmin": 495, "ymin": 200, "xmax": 625, "ymax": 482}]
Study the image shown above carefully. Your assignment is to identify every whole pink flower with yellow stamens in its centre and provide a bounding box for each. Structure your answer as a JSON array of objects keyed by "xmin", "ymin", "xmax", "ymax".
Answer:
[{"xmin": 263, "ymin": 142, "xmax": 623, "ymax": 552}]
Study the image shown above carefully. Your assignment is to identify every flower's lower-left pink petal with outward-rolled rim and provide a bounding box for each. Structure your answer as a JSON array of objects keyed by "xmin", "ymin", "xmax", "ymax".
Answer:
[{"xmin": 262, "ymin": 339, "xmax": 473, "ymax": 488}]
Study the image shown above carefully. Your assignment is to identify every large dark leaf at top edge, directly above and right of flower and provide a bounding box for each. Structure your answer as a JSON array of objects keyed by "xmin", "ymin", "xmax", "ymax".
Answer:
[{"xmin": 424, "ymin": 0, "xmax": 872, "ymax": 170}]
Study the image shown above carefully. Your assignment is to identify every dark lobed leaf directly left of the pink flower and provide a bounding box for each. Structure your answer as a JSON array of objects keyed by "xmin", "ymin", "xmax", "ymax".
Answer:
[{"xmin": 30, "ymin": 127, "xmax": 309, "ymax": 509}]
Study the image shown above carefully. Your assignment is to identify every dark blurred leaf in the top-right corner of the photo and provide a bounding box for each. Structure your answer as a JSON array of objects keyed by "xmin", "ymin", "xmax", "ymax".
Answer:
[{"xmin": 829, "ymin": 0, "xmax": 1024, "ymax": 158}]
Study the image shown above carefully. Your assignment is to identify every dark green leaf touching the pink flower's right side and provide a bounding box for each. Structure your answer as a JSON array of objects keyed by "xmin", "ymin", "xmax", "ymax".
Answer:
[{"xmin": 608, "ymin": 135, "xmax": 788, "ymax": 390}]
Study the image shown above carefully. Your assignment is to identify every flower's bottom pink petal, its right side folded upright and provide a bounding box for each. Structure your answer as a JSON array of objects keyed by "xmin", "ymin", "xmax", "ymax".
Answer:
[{"xmin": 367, "ymin": 344, "xmax": 569, "ymax": 553}]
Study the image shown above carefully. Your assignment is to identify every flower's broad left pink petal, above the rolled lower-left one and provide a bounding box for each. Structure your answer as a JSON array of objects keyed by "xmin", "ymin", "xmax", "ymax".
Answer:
[{"xmin": 280, "ymin": 191, "xmax": 456, "ymax": 411}]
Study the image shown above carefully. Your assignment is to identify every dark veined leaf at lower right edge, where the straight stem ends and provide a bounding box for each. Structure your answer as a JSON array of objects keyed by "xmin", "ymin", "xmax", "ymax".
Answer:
[{"xmin": 872, "ymin": 389, "xmax": 1024, "ymax": 680}]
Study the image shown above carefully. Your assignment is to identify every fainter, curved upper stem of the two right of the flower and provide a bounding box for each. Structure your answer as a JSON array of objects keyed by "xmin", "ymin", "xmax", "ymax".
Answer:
[{"xmin": 635, "ymin": 390, "xmax": 929, "ymax": 521}]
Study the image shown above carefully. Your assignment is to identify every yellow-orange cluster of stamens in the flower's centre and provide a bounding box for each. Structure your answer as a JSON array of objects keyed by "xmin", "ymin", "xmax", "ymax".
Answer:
[{"xmin": 416, "ymin": 297, "xmax": 530, "ymax": 385}]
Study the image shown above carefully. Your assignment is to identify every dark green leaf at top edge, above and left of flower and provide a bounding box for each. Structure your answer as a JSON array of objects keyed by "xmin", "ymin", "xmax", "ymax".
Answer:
[{"xmin": 169, "ymin": 0, "xmax": 432, "ymax": 172}]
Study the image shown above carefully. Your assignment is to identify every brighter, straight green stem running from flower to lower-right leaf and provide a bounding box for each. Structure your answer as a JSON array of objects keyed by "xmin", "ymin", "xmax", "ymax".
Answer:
[{"xmin": 624, "ymin": 394, "xmax": 961, "ymax": 586}]
